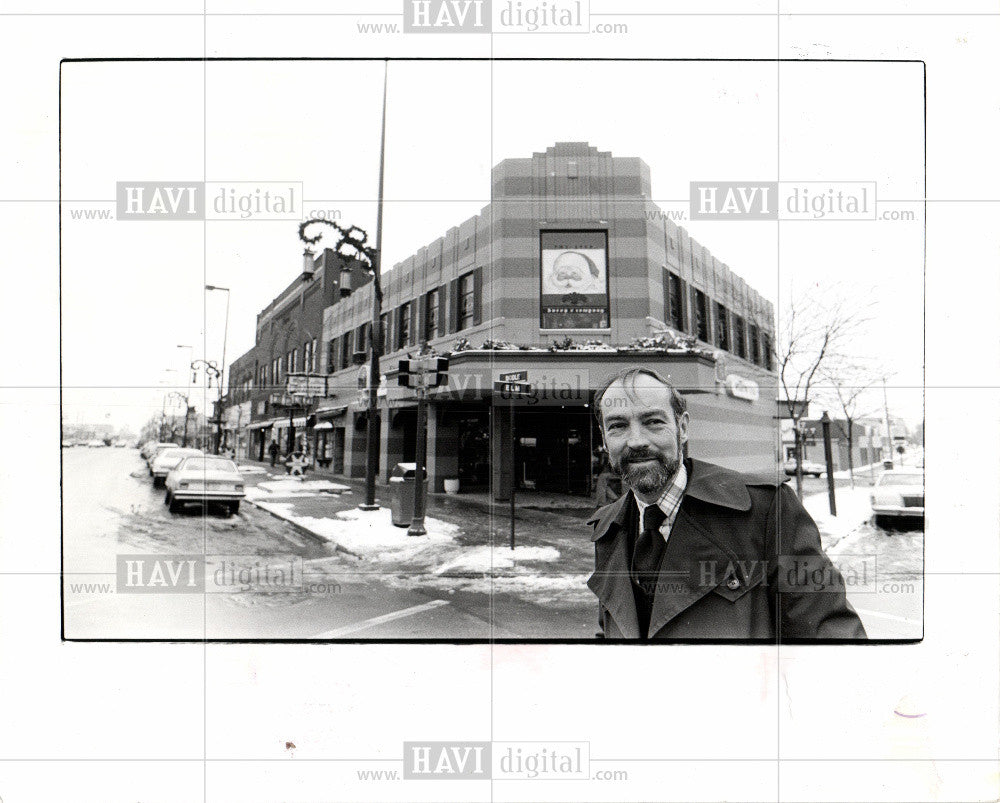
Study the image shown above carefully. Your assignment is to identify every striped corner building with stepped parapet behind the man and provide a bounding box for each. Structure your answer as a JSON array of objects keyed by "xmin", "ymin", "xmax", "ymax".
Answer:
[{"xmin": 236, "ymin": 142, "xmax": 780, "ymax": 500}]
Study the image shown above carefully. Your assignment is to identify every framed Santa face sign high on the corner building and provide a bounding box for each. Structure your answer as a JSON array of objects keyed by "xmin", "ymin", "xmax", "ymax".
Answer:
[{"xmin": 541, "ymin": 230, "xmax": 611, "ymax": 329}]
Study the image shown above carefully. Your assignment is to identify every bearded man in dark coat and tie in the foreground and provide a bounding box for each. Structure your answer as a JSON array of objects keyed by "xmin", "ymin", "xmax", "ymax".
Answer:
[{"xmin": 587, "ymin": 367, "xmax": 867, "ymax": 641}]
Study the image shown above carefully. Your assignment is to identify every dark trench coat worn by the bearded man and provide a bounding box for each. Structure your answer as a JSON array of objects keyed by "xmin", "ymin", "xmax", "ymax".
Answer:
[{"xmin": 587, "ymin": 459, "xmax": 867, "ymax": 642}]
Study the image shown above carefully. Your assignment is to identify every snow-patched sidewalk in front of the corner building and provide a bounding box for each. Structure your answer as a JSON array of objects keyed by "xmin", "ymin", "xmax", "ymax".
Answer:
[{"xmin": 232, "ymin": 461, "xmax": 594, "ymax": 606}]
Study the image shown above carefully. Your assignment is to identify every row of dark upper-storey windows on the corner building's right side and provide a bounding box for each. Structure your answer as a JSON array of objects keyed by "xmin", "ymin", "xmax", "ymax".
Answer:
[{"xmin": 663, "ymin": 270, "xmax": 773, "ymax": 371}]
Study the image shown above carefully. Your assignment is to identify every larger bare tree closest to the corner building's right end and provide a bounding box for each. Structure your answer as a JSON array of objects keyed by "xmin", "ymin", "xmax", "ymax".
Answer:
[{"xmin": 777, "ymin": 287, "xmax": 871, "ymax": 497}]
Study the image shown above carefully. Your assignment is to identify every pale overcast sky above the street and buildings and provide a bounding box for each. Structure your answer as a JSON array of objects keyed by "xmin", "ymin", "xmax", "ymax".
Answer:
[{"xmin": 62, "ymin": 62, "xmax": 924, "ymax": 429}]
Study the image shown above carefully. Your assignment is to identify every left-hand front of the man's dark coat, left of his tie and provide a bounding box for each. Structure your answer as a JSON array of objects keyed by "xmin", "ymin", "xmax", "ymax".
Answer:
[{"xmin": 587, "ymin": 493, "xmax": 639, "ymax": 639}]
